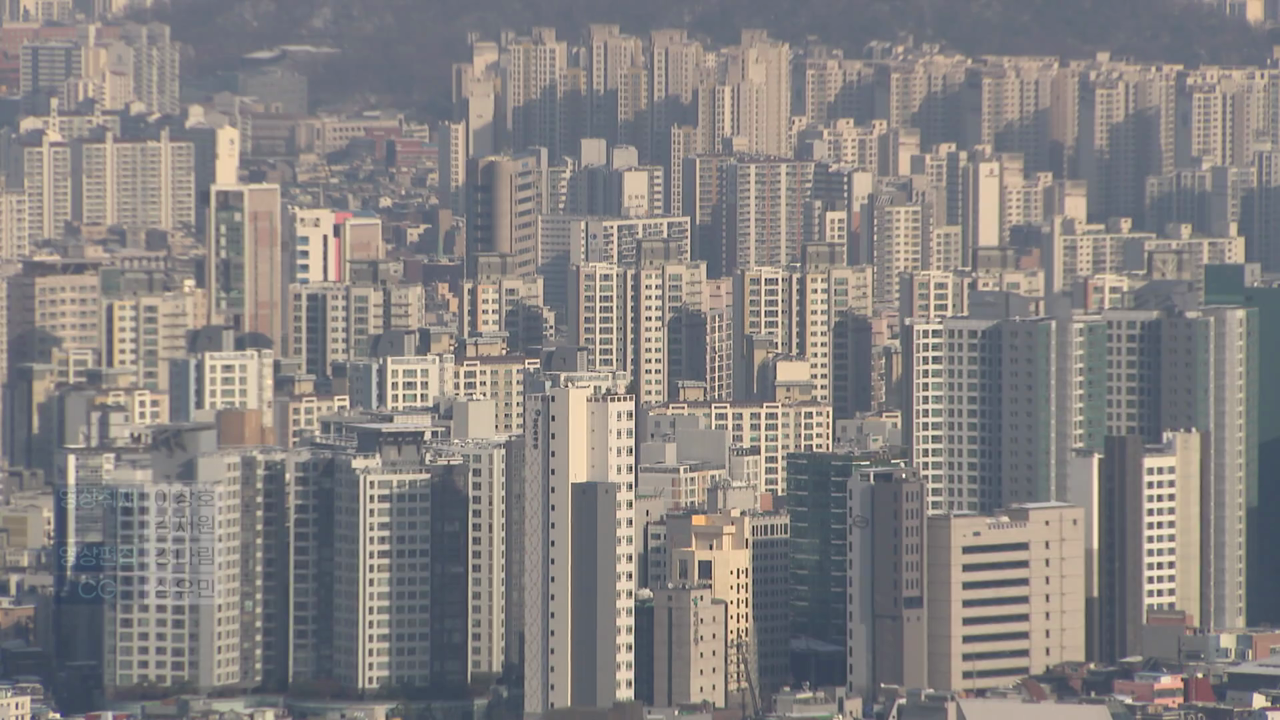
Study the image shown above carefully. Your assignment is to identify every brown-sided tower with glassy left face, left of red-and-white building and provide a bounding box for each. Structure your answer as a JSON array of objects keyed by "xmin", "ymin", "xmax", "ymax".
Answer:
[{"xmin": 205, "ymin": 184, "xmax": 285, "ymax": 348}]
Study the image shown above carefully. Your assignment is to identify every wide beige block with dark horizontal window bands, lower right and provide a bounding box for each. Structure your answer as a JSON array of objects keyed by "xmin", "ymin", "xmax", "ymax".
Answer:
[{"xmin": 925, "ymin": 502, "xmax": 1085, "ymax": 691}]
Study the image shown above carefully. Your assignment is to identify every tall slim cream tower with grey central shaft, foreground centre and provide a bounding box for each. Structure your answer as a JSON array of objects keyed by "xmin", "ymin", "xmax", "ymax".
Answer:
[{"xmin": 522, "ymin": 373, "xmax": 641, "ymax": 716}]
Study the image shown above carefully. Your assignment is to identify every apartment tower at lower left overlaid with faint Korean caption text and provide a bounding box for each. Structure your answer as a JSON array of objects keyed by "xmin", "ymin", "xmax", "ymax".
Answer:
[{"xmin": 99, "ymin": 427, "xmax": 287, "ymax": 692}]
